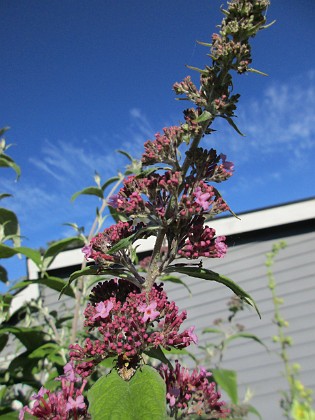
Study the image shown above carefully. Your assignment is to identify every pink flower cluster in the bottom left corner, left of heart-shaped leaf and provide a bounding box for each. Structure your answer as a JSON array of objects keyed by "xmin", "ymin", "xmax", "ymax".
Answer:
[{"xmin": 19, "ymin": 363, "xmax": 90, "ymax": 420}]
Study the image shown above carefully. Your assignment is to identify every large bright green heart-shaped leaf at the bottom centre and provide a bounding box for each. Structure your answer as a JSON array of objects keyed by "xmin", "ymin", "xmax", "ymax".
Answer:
[{"xmin": 88, "ymin": 365, "xmax": 166, "ymax": 420}]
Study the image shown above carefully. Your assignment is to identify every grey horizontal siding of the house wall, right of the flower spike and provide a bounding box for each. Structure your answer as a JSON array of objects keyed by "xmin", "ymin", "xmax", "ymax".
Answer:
[{"xmin": 167, "ymin": 225, "xmax": 315, "ymax": 420}]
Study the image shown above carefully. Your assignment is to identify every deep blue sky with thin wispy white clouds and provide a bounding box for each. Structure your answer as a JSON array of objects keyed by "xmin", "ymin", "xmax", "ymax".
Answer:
[{"xmin": 0, "ymin": 0, "xmax": 315, "ymax": 286}]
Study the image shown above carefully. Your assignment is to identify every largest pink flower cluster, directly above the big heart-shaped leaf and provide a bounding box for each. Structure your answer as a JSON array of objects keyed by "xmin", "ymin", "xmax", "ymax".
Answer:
[{"xmin": 70, "ymin": 279, "xmax": 197, "ymax": 377}]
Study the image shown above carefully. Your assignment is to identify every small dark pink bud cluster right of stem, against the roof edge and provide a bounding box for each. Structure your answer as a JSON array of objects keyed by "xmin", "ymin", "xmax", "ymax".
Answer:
[{"xmin": 178, "ymin": 217, "xmax": 227, "ymax": 259}]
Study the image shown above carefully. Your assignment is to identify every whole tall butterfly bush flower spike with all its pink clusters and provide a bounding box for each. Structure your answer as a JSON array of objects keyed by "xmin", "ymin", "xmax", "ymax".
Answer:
[{"xmin": 20, "ymin": 0, "xmax": 269, "ymax": 419}]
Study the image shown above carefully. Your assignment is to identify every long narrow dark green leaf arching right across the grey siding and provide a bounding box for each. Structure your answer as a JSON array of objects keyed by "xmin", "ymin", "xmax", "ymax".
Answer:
[{"xmin": 165, "ymin": 264, "xmax": 261, "ymax": 318}]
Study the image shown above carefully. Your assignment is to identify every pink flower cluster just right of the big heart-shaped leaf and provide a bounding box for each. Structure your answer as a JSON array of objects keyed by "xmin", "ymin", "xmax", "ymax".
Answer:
[{"xmin": 159, "ymin": 361, "xmax": 229, "ymax": 419}]
